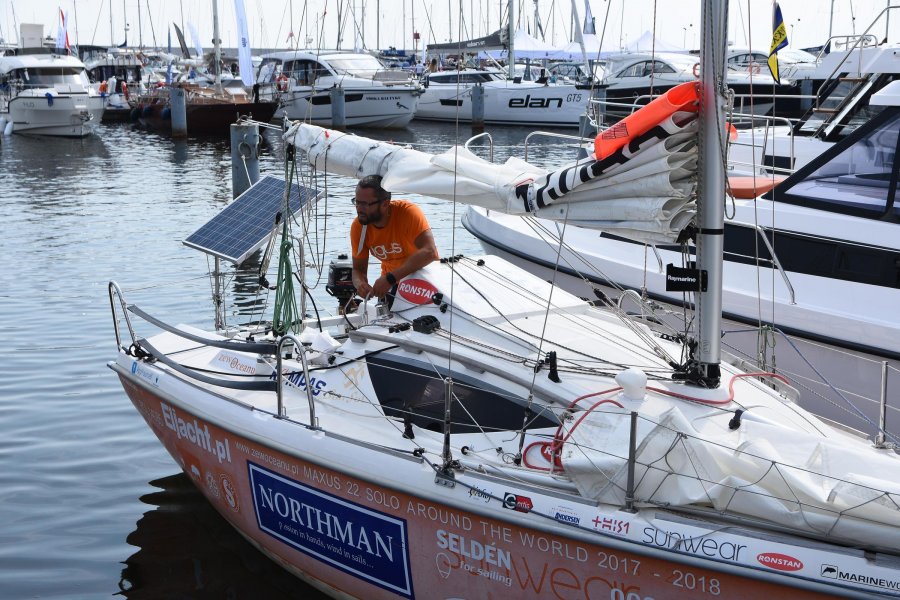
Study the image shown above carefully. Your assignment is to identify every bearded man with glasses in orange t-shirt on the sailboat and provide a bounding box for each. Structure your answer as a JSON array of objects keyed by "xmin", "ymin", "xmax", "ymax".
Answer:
[{"xmin": 350, "ymin": 175, "xmax": 438, "ymax": 298}]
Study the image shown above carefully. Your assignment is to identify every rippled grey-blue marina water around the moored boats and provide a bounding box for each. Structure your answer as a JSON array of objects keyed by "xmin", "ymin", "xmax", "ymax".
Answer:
[{"xmin": 0, "ymin": 122, "xmax": 896, "ymax": 599}]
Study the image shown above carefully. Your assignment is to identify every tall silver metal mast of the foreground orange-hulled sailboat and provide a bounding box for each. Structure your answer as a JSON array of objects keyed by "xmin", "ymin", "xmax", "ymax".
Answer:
[{"xmin": 697, "ymin": 0, "xmax": 728, "ymax": 387}]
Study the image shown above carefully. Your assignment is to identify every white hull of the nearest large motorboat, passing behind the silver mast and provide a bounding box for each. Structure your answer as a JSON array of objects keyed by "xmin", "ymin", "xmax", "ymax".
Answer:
[{"xmin": 463, "ymin": 205, "xmax": 900, "ymax": 356}]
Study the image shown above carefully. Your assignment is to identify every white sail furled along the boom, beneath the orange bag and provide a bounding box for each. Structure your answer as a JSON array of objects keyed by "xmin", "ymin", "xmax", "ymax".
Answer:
[{"xmin": 284, "ymin": 113, "xmax": 697, "ymax": 243}]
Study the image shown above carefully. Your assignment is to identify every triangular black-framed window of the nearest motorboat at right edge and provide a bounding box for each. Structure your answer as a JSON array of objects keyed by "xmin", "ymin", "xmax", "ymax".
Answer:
[{"xmin": 784, "ymin": 111, "xmax": 900, "ymax": 218}]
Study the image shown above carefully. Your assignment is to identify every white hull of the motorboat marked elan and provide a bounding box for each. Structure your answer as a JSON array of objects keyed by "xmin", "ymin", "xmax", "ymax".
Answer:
[{"xmin": 416, "ymin": 80, "xmax": 591, "ymax": 127}]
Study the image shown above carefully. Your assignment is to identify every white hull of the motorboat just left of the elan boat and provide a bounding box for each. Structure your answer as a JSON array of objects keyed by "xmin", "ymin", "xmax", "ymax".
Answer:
[{"xmin": 275, "ymin": 87, "xmax": 419, "ymax": 128}]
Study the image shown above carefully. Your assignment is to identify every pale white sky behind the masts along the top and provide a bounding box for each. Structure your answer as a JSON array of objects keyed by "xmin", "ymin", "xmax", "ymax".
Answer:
[{"xmin": 0, "ymin": 0, "xmax": 900, "ymax": 50}]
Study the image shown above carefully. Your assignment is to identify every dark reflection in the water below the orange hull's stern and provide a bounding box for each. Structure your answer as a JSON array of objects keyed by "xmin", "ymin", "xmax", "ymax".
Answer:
[{"xmin": 117, "ymin": 473, "xmax": 324, "ymax": 600}]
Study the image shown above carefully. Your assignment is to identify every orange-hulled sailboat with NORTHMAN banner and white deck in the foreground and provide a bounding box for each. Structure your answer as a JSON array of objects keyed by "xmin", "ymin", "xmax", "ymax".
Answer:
[{"xmin": 109, "ymin": 0, "xmax": 900, "ymax": 600}]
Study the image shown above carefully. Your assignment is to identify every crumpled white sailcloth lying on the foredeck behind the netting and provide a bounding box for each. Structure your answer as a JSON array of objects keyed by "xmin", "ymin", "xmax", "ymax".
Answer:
[{"xmin": 561, "ymin": 403, "xmax": 900, "ymax": 549}]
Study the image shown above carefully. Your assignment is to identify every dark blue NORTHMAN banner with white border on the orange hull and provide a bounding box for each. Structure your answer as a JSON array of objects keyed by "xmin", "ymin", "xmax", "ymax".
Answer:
[{"xmin": 247, "ymin": 462, "xmax": 413, "ymax": 598}]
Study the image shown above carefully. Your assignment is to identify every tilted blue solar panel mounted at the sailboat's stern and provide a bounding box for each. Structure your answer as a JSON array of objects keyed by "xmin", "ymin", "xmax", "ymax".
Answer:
[{"xmin": 184, "ymin": 176, "xmax": 318, "ymax": 265}]
